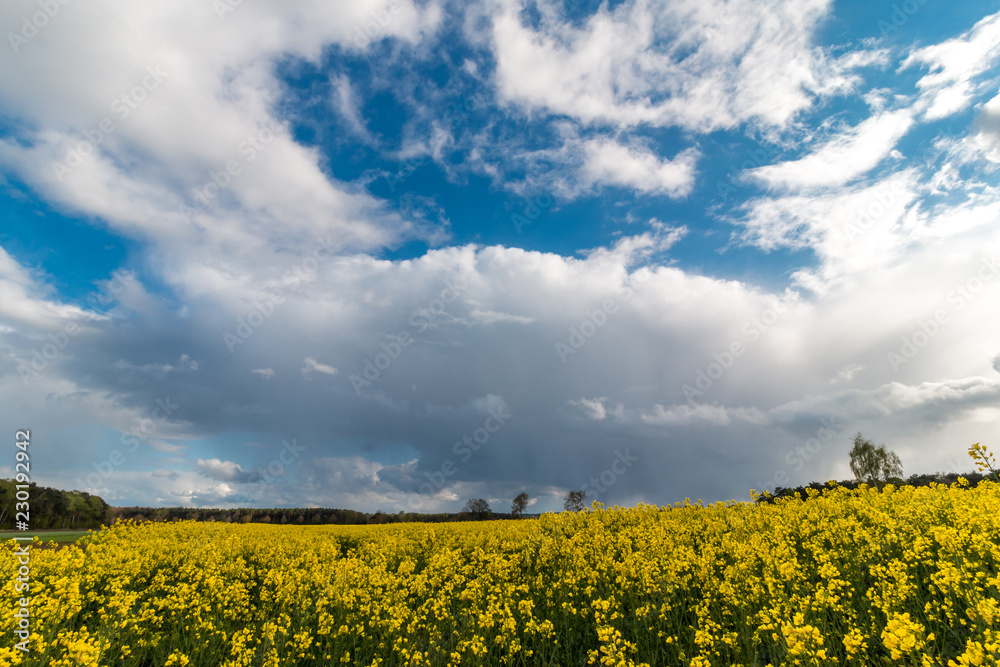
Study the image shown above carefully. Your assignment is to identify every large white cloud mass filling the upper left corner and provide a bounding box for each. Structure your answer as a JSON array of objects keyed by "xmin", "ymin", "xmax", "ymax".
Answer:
[{"xmin": 0, "ymin": 0, "xmax": 441, "ymax": 303}]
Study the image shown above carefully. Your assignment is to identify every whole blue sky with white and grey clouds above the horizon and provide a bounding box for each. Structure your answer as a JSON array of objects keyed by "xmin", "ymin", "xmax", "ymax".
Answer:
[{"xmin": 0, "ymin": 0, "xmax": 1000, "ymax": 513}]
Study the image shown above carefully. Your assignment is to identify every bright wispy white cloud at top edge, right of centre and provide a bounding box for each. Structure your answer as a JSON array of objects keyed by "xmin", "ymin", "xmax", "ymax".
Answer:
[{"xmin": 492, "ymin": 0, "xmax": 864, "ymax": 132}]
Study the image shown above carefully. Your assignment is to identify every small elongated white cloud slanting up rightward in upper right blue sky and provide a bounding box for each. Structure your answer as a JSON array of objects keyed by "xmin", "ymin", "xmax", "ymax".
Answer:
[{"xmin": 745, "ymin": 110, "xmax": 913, "ymax": 188}]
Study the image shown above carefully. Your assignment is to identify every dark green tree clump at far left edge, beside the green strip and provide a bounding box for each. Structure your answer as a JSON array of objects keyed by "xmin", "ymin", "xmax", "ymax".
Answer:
[{"xmin": 0, "ymin": 479, "xmax": 111, "ymax": 530}]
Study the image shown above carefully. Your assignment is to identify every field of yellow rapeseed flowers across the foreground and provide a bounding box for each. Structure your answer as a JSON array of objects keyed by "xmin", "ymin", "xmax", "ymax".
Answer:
[{"xmin": 0, "ymin": 480, "xmax": 1000, "ymax": 667}]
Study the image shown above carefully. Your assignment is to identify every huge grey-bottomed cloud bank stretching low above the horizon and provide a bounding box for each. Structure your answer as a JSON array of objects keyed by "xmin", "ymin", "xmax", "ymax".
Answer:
[{"xmin": 0, "ymin": 215, "xmax": 1000, "ymax": 511}]
